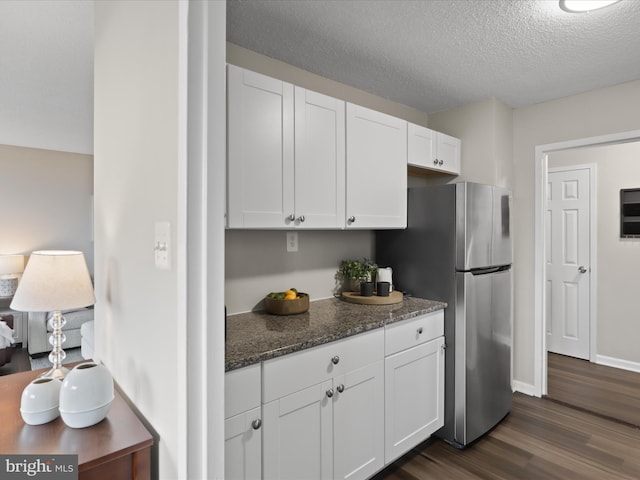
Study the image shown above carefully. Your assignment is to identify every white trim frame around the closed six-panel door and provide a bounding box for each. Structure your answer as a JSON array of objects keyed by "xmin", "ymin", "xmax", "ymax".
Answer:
[{"xmin": 543, "ymin": 165, "xmax": 598, "ymax": 362}]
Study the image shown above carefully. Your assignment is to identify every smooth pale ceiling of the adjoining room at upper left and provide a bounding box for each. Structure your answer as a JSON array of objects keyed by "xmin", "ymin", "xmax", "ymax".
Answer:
[{"xmin": 0, "ymin": 0, "xmax": 94, "ymax": 154}]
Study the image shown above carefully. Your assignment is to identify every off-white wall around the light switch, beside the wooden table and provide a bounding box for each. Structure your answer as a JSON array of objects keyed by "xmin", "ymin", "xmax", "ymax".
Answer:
[{"xmin": 94, "ymin": 0, "xmax": 186, "ymax": 479}]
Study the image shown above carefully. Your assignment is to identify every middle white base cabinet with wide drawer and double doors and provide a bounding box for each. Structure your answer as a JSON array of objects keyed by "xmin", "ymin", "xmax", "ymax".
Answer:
[{"xmin": 263, "ymin": 329, "xmax": 384, "ymax": 480}]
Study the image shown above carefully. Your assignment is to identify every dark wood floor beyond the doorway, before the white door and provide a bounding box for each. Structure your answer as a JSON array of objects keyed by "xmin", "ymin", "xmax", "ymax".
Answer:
[{"xmin": 547, "ymin": 353, "xmax": 640, "ymax": 427}]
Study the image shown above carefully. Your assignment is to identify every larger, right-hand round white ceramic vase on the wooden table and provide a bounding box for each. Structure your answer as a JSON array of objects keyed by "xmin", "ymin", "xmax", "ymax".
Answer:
[{"xmin": 60, "ymin": 362, "xmax": 114, "ymax": 428}]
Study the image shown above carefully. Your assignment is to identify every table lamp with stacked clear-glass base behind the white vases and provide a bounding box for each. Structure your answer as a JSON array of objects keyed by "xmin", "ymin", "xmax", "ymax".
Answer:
[{"xmin": 11, "ymin": 250, "xmax": 96, "ymax": 379}]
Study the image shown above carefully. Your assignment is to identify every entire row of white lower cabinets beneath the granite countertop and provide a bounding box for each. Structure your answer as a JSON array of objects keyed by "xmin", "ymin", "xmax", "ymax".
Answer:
[{"xmin": 225, "ymin": 311, "xmax": 444, "ymax": 480}]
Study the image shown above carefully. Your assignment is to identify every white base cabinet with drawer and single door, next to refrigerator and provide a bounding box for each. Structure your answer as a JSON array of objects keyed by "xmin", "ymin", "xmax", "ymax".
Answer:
[{"xmin": 385, "ymin": 312, "xmax": 444, "ymax": 463}]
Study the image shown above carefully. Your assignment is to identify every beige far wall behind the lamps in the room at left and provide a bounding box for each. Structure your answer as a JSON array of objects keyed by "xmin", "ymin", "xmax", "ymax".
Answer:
[{"xmin": 0, "ymin": 145, "xmax": 93, "ymax": 272}]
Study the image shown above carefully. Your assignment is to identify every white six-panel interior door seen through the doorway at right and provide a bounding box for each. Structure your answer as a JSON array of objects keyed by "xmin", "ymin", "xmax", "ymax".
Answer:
[{"xmin": 546, "ymin": 168, "xmax": 592, "ymax": 360}]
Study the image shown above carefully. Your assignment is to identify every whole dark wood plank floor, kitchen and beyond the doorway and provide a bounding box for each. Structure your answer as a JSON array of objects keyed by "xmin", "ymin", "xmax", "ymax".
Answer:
[{"xmin": 375, "ymin": 357, "xmax": 640, "ymax": 480}]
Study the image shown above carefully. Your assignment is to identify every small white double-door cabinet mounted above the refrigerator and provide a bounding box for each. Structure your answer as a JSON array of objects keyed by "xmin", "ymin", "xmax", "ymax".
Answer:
[{"xmin": 407, "ymin": 123, "xmax": 461, "ymax": 175}]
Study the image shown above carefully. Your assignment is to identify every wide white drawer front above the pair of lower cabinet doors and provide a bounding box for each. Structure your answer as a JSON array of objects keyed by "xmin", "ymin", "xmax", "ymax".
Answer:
[{"xmin": 262, "ymin": 328, "xmax": 384, "ymax": 403}]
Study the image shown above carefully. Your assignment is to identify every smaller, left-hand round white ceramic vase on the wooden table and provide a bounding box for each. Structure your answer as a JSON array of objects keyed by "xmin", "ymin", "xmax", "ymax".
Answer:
[{"xmin": 20, "ymin": 378, "xmax": 62, "ymax": 425}]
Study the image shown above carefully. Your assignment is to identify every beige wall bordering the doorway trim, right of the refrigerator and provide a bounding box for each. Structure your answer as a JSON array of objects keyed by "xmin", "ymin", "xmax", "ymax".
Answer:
[{"xmin": 513, "ymin": 81, "xmax": 640, "ymax": 385}]
